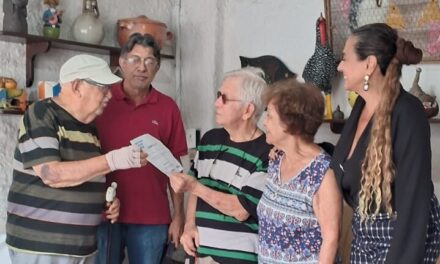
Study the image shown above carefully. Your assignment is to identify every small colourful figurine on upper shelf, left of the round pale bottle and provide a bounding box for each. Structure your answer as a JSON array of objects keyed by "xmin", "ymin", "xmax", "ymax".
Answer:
[{"xmin": 43, "ymin": 0, "xmax": 63, "ymax": 38}]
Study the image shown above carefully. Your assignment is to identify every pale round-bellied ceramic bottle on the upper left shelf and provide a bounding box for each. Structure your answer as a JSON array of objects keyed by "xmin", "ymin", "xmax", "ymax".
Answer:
[{"xmin": 72, "ymin": 0, "xmax": 104, "ymax": 44}]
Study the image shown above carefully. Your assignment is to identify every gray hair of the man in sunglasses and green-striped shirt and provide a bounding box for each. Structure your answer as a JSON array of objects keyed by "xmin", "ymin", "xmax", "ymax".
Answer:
[{"xmin": 223, "ymin": 67, "xmax": 267, "ymax": 120}]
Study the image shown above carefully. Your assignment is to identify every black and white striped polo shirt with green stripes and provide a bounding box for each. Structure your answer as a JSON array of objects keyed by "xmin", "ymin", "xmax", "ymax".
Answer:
[{"xmin": 190, "ymin": 129, "xmax": 271, "ymax": 264}]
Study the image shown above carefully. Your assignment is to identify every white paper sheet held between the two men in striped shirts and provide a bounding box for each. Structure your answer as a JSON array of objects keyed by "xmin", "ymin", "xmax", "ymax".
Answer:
[{"xmin": 130, "ymin": 134, "xmax": 183, "ymax": 177}]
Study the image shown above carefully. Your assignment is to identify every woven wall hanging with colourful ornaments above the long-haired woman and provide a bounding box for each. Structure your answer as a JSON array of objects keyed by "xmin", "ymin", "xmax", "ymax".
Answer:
[{"xmin": 324, "ymin": 0, "xmax": 440, "ymax": 62}]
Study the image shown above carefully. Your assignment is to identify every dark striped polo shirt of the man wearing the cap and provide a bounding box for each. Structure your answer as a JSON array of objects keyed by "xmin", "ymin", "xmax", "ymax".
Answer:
[{"xmin": 6, "ymin": 99, "xmax": 105, "ymax": 256}]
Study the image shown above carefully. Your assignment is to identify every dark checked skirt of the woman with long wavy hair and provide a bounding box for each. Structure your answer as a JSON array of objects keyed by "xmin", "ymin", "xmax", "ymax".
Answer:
[{"xmin": 350, "ymin": 196, "xmax": 440, "ymax": 264}]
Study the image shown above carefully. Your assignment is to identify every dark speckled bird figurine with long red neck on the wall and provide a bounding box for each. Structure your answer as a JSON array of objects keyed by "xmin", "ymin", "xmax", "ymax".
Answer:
[{"xmin": 302, "ymin": 13, "xmax": 337, "ymax": 120}]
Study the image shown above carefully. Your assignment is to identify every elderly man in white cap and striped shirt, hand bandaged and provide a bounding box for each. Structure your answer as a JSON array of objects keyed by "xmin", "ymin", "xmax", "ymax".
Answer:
[{"xmin": 6, "ymin": 55, "xmax": 147, "ymax": 264}]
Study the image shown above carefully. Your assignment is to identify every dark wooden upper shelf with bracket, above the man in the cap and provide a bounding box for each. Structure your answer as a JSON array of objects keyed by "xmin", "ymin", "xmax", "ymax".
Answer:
[{"xmin": 0, "ymin": 31, "xmax": 174, "ymax": 87}]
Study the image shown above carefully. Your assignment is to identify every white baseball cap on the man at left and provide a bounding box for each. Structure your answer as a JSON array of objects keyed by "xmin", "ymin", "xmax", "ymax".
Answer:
[{"xmin": 60, "ymin": 54, "xmax": 122, "ymax": 85}]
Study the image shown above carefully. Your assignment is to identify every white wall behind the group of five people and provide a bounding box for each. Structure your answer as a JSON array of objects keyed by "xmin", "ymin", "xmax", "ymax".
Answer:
[{"xmin": 0, "ymin": 0, "xmax": 440, "ymax": 263}]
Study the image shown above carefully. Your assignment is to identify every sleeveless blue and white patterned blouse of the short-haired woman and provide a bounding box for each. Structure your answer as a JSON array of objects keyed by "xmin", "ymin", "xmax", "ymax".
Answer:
[{"xmin": 257, "ymin": 152, "xmax": 331, "ymax": 264}]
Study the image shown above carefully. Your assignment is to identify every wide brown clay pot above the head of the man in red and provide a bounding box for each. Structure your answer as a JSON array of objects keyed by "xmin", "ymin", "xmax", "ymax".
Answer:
[{"xmin": 117, "ymin": 16, "xmax": 173, "ymax": 49}]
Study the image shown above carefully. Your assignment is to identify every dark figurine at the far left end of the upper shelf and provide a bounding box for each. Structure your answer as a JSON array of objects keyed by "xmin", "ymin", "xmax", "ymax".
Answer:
[{"xmin": 3, "ymin": 0, "xmax": 28, "ymax": 34}]
